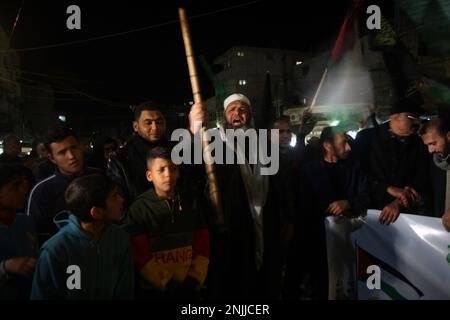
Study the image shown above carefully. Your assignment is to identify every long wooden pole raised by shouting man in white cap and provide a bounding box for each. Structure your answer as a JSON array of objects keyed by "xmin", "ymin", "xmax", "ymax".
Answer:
[{"xmin": 178, "ymin": 8, "xmax": 225, "ymax": 228}]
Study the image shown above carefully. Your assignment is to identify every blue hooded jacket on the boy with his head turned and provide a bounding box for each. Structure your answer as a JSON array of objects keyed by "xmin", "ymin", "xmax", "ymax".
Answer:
[{"xmin": 31, "ymin": 211, "xmax": 134, "ymax": 300}]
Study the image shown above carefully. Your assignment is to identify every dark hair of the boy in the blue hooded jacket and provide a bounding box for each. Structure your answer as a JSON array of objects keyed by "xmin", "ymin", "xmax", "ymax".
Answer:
[{"xmin": 65, "ymin": 174, "xmax": 117, "ymax": 222}]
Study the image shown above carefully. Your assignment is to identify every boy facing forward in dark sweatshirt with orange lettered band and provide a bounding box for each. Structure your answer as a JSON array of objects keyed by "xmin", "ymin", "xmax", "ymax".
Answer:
[{"xmin": 125, "ymin": 147, "xmax": 209, "ymax": 299}]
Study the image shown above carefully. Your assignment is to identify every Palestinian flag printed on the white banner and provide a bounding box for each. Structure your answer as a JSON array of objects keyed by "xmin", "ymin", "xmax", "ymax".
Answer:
[{"xmin": 356, "ymin": 245, "xmax": 424, "ymax": 300}]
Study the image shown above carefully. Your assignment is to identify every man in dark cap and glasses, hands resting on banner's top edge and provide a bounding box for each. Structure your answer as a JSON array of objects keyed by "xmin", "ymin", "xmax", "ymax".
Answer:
[{"xmin": 355, "ymin": 100, "xmax": 428, "ymax": 224}]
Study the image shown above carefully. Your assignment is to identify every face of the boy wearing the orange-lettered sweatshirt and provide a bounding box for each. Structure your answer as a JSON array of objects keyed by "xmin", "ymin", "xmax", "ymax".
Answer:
[{"xmin": 147, "ymin": 158, "xmax": 179, "ymax": 195}]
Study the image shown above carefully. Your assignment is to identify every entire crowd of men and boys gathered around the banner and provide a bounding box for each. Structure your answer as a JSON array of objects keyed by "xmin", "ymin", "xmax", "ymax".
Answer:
[{"xmin": 0, "ymin": 94, "xmax": 450, "ymax": 301}]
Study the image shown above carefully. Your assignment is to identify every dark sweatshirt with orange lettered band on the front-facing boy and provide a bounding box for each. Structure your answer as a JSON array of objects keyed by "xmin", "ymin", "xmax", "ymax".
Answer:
[{"xmin": 124, "ymin": 189, "xmax": 209, "ymax": 292}]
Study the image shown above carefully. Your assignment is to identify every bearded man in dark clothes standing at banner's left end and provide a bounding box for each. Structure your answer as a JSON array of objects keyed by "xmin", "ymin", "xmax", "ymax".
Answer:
[{"xmin": 287, "ymin": 127, "xmax": 370, "ymax": 299}]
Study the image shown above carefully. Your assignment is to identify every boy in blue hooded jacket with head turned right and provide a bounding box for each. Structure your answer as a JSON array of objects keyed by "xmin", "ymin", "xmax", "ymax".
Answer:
[{"xmin": 31, "ymin": 175, "xmax": 134, "ymax": 300}]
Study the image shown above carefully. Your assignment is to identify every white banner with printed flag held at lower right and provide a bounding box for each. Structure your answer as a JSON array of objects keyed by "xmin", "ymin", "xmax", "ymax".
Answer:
[{"xmin": 325, "ymin": 210, "xmax": 450, "ymax": 300}]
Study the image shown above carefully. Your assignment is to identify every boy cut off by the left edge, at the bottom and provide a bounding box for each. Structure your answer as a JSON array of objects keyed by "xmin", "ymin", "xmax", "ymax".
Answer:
[{"xmin": 0, "ymin": 164, "xmax": 38, "ymax": 300}]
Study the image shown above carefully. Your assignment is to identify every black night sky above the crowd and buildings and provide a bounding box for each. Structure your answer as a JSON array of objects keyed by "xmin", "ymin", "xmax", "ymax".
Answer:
[{"xmin": 0, "ymin": 0, "xmax": 364, "ymax": 110}]
